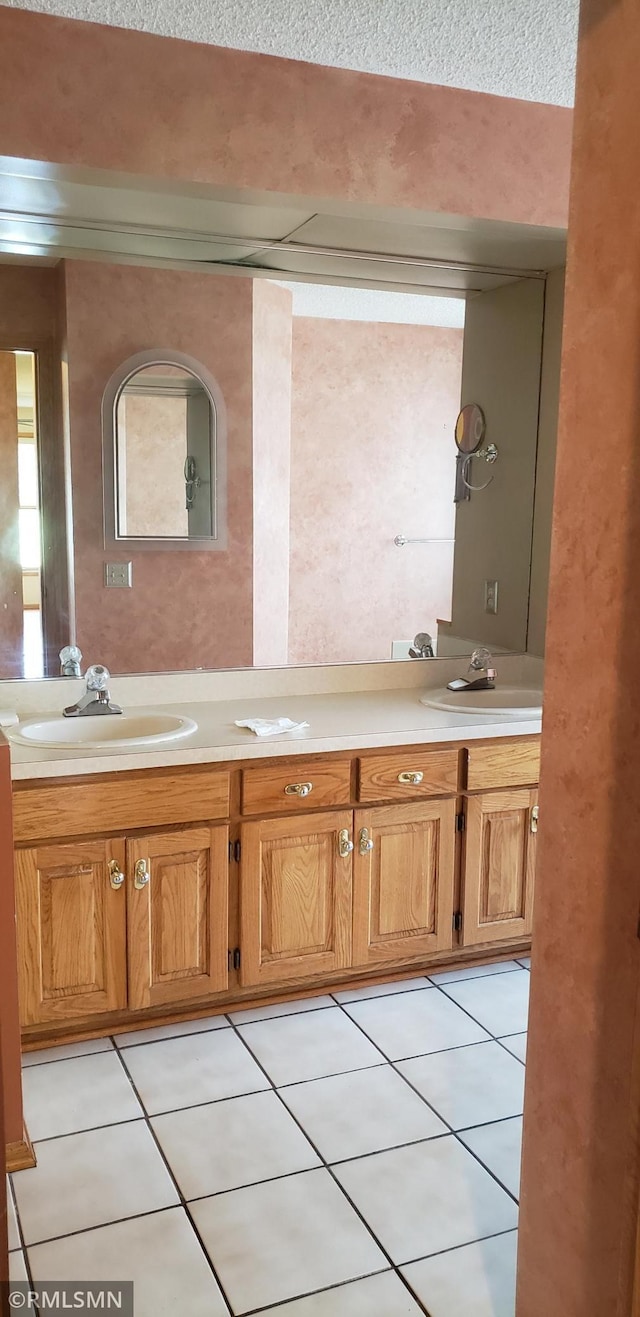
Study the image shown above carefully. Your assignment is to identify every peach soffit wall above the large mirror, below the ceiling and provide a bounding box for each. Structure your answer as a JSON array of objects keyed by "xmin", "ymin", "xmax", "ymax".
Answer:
[{"xmin": 0, "ymin": 5, "xmax": 572, "ymax": 225}]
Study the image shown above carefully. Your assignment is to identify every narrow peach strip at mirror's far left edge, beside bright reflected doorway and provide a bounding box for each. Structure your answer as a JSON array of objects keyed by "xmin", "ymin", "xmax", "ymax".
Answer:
[{"xmin": 0, "ymin": 352, "xmax": 22, "ymax": 677}]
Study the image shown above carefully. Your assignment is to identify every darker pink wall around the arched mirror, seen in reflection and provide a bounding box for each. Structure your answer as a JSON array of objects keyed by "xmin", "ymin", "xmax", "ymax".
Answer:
[{"xmin": 65, "ymin": 261, "xmax": 253, "ymax": 673}]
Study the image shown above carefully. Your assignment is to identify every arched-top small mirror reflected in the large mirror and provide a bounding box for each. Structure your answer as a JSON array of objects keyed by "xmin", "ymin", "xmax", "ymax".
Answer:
[{"xmin": 105, "ymin": 362, "xmax": 217, "ymax": 543}]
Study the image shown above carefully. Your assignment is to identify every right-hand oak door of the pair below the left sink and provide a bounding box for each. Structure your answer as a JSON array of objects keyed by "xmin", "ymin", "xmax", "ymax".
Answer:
[{"xmin": 126, "ymin": 826, "xmax": 229, "ymax": 1010}]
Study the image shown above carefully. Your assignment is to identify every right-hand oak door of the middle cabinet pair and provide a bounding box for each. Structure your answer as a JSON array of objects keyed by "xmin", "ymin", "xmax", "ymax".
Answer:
[{"xmin": 353, "ymin": 799, "xmax": 456, "ymax": 965}]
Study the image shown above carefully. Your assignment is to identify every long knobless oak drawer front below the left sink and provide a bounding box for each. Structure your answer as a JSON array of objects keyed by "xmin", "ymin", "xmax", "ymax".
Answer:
[{"xmin": 13, "ymin": 769, "xmax": 229, "ymax": 843}]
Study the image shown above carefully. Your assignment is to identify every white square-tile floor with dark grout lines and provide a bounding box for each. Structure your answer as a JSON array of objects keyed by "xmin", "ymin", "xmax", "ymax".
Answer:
[{"xmin": 9, "ymin": 960, "xmax": 529, "ymax": 1317}]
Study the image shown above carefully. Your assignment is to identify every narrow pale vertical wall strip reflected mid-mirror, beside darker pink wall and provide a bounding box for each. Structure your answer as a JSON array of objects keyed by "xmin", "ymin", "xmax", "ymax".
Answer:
[{"xmin": 253, "ymin": 279, "xmax": 292, "ymax": 666}]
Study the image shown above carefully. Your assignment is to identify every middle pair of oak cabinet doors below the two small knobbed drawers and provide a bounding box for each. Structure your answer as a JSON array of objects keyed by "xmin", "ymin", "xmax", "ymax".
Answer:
[{"xmin": 240, "ymin": 799, "xmax": 456, "ymax": 986}]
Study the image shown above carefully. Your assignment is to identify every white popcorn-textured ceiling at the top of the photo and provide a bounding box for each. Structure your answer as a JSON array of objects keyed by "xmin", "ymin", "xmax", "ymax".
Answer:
[{"xmin": 3, "ymin": 0, "xmax": 578, "ymax": 105}]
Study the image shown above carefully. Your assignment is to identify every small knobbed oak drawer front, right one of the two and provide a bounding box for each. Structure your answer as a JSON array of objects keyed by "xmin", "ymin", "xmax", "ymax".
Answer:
[{"xmin": 358, "ymin": 749, "xmax": 460, "ymax": 803}]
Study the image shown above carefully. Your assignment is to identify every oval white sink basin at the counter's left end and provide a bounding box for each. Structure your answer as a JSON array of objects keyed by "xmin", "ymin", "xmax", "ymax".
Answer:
[{"xmin": 5, "ymin": 712, "xmax": 198, "ymax": 749}]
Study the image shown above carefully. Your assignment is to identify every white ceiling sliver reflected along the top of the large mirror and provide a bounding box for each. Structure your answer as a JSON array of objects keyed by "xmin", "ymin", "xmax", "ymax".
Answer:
[{"xmin": 277, "ymin": 279, "xmax": 465, "ymax": 329}]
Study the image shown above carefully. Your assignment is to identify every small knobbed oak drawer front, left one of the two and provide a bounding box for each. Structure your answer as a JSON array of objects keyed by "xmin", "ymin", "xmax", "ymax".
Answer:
[{"xmin": 242, "ymin": 759, "xmax": 352, "ymax": 814}]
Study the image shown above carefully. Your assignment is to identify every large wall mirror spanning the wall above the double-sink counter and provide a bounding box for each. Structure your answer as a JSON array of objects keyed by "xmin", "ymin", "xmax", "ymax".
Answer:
[{"xmin": 0, "ymin": 247, "xmax": 562, "ymax": 678}]
